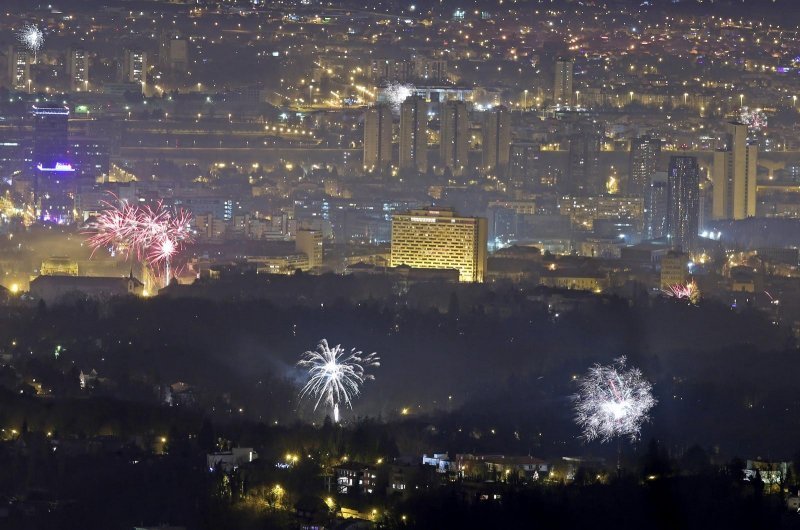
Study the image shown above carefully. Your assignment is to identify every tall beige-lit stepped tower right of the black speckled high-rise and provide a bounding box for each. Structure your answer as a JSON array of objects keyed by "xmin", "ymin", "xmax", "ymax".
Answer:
[{"xmin": 712, "ymin": 122, "xmax": 758, "ymax": 220}]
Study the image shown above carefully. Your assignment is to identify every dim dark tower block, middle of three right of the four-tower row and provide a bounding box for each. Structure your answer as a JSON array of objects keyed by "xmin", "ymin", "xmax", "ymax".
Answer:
[{"xmin": 561, "ymin": 124, "xmax": 604, "ymax": 195}]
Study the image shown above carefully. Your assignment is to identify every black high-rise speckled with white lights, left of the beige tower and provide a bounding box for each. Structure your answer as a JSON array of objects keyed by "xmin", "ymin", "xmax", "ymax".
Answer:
[{"xmin": 667, "ymin": 156, "xmax": 700, "ymax": 251}]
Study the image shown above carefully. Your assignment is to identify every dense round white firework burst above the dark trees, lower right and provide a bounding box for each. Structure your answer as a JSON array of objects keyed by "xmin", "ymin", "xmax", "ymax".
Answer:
[{"xmin": 573, "ymin": 356, "xmax": 656, "ymax": 443}]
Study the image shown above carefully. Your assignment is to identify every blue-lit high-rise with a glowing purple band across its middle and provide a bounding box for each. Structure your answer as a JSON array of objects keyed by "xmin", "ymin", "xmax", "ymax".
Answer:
[{"xmin": 31, "ymin": 104, "xmax": 75, "ymax": 223}]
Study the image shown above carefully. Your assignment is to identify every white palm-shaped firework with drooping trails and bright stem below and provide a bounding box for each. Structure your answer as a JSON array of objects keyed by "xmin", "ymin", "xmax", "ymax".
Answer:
[{"xmin": 297, "ymin": 339, "xmax": 380, "ymax": 422}]
